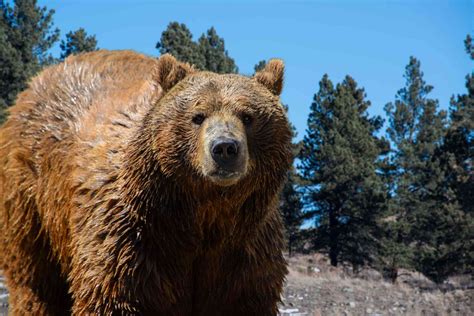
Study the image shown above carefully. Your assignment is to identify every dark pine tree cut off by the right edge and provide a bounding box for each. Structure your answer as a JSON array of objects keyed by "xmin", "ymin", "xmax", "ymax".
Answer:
[{"xmin": 426, "ymin": 35, "xmax": 474, "ymax": 282}]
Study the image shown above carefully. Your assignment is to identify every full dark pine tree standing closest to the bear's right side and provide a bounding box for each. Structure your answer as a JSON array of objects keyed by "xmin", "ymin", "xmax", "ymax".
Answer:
[{"xmin": 299, "ymin": 75, "xmax": 386, "ymax": 269}]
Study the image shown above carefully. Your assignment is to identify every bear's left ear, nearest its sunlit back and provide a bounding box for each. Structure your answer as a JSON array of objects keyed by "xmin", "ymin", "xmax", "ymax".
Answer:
[{"xmin": 156, "ymin": 54, "xmax": 194, "ymax": 92}]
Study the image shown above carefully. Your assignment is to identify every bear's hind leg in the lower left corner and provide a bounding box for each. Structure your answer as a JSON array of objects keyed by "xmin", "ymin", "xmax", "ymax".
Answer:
[{"xmin": 0, "ymin": 201, "xmax": 71, "ymax": 315}]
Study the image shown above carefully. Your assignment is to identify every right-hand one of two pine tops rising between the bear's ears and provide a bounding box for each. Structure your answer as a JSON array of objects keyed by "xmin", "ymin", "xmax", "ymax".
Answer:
[{"xmin": 198, "ymin": 27, "xmax": 238, "ymax": 73}]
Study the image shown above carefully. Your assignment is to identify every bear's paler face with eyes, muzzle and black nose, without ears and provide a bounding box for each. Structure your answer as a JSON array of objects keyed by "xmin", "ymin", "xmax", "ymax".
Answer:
[{"xmin": 191, "ymin": 81, "xmax": 255, "ymax": 186}]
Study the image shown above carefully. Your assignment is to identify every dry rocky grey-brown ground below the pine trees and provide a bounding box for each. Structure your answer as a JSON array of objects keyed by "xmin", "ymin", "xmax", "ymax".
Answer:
[{"xmin": 0, "ymin": 254, "xmax": 474, "ymax": 316}]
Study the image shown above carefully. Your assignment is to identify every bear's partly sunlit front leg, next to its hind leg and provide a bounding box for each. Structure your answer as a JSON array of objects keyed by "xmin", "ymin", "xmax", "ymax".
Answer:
[{"xmin": 66, "ymin": 218, "xmax": 192, "ymax": 316}]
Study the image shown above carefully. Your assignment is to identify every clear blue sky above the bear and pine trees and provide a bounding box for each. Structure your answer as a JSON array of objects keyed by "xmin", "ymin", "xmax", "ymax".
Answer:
[{"xmin": 43, "ymin": 0, "xmax": 474, "ymax": 138}]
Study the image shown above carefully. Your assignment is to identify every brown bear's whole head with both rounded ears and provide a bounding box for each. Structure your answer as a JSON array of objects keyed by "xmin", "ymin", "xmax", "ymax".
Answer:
[{"xmin": 150, "ymin": 55, "xmax": 291, "ymax": 187}]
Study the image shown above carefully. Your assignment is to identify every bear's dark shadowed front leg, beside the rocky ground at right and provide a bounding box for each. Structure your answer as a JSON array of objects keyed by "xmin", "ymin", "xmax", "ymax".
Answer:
[{"xmin": 193, "ymin": 214, "xmax": 287, "ymax": 316}]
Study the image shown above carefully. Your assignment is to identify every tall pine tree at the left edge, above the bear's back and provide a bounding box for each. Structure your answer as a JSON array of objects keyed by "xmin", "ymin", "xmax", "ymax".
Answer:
[{"xmin": 0, "ymin": 0, "xmax": 59, "ymax": 122}]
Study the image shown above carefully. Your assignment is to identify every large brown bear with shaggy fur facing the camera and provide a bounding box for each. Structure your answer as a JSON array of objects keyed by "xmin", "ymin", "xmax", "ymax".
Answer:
[{"xmin": 0, "ymin": 50, "xmax": 291, "ymax": 315}]
